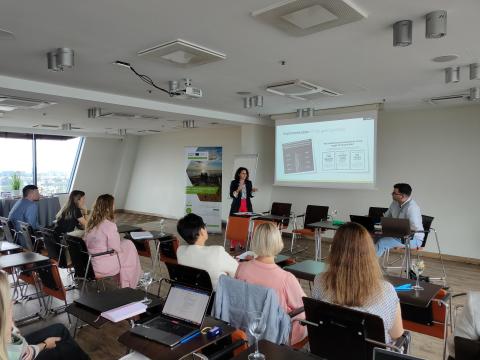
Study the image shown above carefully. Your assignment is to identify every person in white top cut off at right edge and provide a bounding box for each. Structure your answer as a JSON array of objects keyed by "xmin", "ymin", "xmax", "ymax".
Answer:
[{"xmin": 448, "ymin": 291, "xmax": 480, "ymax": 358}]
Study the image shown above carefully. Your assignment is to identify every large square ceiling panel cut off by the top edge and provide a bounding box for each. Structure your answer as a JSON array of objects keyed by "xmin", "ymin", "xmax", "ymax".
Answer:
[{"xmin": 252, "ymin": 0, "xmax": 367, "ymax": 36}]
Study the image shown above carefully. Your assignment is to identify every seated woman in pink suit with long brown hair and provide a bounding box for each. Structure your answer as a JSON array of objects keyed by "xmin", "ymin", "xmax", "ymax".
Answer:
[{"xmin": 84, "ymin": 194, "xmax": 142, "ymax": 289}]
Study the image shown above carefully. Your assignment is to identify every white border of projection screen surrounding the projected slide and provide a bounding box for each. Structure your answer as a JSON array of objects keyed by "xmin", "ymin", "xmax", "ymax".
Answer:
[{"xmin": 273, "ymin": 109, "xmax": 378, "ymax": 190}]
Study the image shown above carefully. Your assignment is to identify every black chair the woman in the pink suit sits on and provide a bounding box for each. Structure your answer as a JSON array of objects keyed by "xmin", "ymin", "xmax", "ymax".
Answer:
[{"xmin": 65, "ymin": 235, "xmax": 121, "ymax": 294}]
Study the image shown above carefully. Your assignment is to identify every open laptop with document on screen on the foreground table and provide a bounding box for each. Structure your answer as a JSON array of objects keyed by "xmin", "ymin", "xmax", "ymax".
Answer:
[{"xmin": 130, "ymin": 282, "xmax": 211, "ymax": 347}]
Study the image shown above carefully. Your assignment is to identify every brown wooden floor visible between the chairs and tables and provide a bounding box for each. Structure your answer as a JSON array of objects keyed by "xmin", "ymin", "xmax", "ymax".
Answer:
[{"xmin": 14, "ymin": 214, "xmax": 480, "ymax": 360}]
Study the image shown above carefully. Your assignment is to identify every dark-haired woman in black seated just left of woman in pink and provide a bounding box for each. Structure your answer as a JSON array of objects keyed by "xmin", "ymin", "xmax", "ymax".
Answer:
[{"xmin": 55, "ymin": 190, "xmax": 87, "ymax": 237}]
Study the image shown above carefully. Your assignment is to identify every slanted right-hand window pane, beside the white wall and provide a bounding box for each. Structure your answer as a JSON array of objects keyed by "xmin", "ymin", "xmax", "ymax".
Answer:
[{"xmin": 36, "ymin": 138, "xmax": 81, "ymax": 195}]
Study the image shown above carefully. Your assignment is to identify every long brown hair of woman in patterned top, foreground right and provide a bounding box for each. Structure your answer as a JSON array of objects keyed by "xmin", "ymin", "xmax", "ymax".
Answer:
[{"xmin": 321, "ymin": 222, "xmax": 383, "ymax": 306}]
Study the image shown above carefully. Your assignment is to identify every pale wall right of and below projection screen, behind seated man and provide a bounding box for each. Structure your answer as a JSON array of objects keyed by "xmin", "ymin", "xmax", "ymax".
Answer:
[{"xmin": 271, "ymin": 106, "xmax": 480, "ymax": 258}]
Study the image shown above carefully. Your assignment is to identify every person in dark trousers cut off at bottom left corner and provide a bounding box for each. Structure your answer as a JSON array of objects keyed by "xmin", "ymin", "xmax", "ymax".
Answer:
[{"xmin": 0, "ymin": 271, "xmax": 89, "ymax": 360}]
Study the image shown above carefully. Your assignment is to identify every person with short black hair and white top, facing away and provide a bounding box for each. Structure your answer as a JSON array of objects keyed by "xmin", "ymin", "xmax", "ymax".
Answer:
[{"xmin": 177, "ymin": 213, "xmax": 238, "ymax": 290}]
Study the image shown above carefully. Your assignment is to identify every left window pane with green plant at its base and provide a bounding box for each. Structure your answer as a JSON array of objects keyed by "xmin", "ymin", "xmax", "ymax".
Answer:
[{"xmin": 0, "ymin": 138, "xmax": 33, "ymax": 192}]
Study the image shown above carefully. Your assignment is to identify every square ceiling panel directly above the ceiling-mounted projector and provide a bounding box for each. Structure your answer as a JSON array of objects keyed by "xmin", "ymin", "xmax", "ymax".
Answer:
[{"xmin": 138, "ymin": 39, "xmax": 227, "ymax": 67}]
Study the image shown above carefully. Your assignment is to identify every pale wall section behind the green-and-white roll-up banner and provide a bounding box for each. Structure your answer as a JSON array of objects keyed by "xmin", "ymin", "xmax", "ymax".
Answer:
[{"xmin": 125, "ymin": 127, "xmax": 241, "ymax": 218}]
